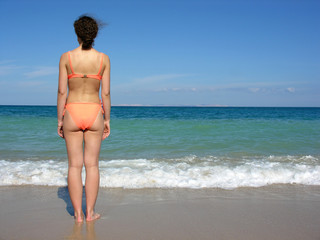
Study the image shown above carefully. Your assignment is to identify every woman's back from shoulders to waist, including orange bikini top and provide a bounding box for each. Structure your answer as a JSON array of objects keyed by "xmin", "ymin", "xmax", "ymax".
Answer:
[{"xmin": 67, "ymin": 48, "xmax": 104, "ymax": 103}]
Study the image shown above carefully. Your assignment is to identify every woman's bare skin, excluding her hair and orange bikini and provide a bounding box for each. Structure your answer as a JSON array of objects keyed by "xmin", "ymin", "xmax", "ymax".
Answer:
[{"xmin": 57, "ymin": 42, "xmax": 110, "ymax": 222}]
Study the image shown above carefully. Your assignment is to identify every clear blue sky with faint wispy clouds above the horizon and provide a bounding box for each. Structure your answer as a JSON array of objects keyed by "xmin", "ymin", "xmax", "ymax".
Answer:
[{"xmin": 0, "ymin": 0, "xmax": 320, "ymax": 107}]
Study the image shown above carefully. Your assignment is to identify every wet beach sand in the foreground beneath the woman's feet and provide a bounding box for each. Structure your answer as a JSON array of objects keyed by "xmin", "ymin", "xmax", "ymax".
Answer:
[{"xmin": 0, "ymin": 185, "xmax": 320, "ymax": 240}]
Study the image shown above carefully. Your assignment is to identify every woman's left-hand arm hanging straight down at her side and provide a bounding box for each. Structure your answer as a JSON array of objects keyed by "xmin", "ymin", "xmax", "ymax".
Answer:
[{"xmin": 57, "ymin": 53, "xmax": 68, "ymax": 138}]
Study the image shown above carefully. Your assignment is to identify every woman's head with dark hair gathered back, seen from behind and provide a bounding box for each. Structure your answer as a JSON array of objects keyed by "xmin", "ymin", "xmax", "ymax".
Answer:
[{"xmin": 73, "ymin": 15, "xmax": 99, "ymax": 50}]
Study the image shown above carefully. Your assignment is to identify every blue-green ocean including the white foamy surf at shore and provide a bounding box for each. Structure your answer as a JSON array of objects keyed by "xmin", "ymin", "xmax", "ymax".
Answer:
[{"xmin": 0, "ymin": 105, "xmax": 320, "ymax": 189}]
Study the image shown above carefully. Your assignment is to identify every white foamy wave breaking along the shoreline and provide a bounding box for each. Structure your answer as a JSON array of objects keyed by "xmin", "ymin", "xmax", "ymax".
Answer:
[{"xmin": 0, "ymin": 156, "xmax": 320, "ymax": 189}]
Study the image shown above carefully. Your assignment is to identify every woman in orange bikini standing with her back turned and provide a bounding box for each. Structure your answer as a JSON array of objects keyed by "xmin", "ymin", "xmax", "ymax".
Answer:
[{"xmin": 57, "ymin": 16, "xmax": 110, "ymax": 222}]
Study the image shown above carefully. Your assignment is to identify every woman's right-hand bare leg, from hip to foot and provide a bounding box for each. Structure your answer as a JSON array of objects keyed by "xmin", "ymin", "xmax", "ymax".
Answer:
[{"xmin": 84, "ymin": 111, "xmax": 103, "ymax": 221}]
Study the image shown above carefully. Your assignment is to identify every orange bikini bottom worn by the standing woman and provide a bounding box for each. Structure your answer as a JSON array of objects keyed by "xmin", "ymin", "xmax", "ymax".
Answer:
[{"xmin": 63, "ymin": 102, "xmax": 103, "ymax": 130}]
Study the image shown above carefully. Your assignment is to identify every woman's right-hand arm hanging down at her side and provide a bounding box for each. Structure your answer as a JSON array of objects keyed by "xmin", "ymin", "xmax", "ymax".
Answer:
[{"xmin": 101, "ymin": 55, "xmax": 111, "ymax": 140}]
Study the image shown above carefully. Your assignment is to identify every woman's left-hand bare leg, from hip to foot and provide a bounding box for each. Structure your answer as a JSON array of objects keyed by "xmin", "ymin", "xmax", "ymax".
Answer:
[{"xmin": 63, "ymin": 111, "xmax": 83, "ymax": 222}]
